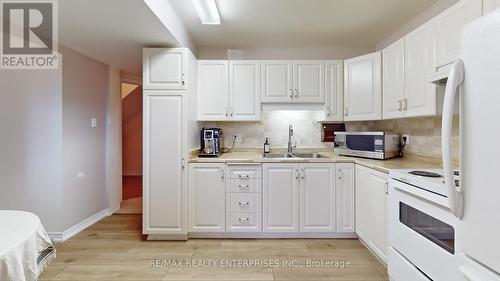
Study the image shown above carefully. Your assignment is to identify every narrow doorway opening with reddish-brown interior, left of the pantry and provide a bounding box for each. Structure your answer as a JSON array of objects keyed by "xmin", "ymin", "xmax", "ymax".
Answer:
[{"xmin": 118, "ymin": 83, "xmax": 142, "ymax": 214}]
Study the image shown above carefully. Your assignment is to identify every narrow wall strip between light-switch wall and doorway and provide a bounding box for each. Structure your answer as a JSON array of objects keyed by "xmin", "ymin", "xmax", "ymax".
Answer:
[{"xmin": 106, "ymin": 67, "xmax": 122, "ymax": 208}]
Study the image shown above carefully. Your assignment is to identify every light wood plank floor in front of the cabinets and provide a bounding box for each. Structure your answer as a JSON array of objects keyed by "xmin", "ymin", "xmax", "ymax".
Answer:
[{"xmin": 40, "ymin": 215, "xmax": 388, "ymax": 281}]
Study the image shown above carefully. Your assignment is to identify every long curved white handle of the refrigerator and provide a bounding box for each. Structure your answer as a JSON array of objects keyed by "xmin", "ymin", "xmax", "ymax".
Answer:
[{"xmin": 441, "ymin": 60, "xmax": 465, "ymax": 218}]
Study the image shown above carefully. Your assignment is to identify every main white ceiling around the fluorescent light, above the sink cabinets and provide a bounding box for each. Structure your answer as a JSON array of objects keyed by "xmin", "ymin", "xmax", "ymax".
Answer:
[{"xmin": 170, "ymin": 0, "xmax": 437, "ymax": 48}]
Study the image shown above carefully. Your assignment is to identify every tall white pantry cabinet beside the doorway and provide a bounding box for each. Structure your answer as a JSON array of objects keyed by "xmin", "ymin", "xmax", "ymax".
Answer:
[{"xmin": 142, "ymin": 48, "xmax": 199, "ymax": 239}]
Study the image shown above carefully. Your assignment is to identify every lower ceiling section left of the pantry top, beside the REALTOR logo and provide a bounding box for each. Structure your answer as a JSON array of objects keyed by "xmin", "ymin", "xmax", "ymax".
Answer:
[{"xmin": 59, "ymin": 0, "xmax": 177, "ymax": 77}]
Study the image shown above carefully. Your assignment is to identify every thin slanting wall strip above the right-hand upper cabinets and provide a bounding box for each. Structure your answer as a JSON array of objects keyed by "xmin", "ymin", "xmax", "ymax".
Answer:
[{"xmin": 376, "ymin": 0, "xmax": 459, "ymax": 50}]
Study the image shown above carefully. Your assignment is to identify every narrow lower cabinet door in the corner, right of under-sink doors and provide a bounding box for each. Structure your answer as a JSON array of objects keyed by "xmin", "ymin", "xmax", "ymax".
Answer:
[{"xmin": 336, "ymin": 163, "xmax": 356, "ymax": 233}]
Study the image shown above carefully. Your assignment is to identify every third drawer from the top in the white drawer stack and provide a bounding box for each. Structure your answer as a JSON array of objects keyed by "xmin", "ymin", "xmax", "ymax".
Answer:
[{"xmin": 226, "ymin": 193, "xmax": 262, "ymax": 213}]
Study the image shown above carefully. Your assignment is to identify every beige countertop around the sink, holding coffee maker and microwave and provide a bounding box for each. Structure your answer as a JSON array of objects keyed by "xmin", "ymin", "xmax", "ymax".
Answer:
[{"xmin": 189, "ymin": 149, "xmax": 448, "ymax": 173}]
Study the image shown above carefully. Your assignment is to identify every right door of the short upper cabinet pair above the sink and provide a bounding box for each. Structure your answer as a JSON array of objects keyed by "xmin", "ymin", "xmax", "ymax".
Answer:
[{"xmin": 293, "ymin": 60, "xmax": 325, "ymax": 103}]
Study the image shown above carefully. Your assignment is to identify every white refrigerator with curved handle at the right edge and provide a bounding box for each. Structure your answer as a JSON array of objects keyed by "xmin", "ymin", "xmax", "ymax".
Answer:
[{"xmin": 442, "ymin": 10, "xmax": 500, "ymax": 281}]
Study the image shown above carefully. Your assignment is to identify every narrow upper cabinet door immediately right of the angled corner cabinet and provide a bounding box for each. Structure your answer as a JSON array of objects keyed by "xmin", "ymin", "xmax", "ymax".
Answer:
[{"xmin": 382, "ymin": 39, "xmax": 405, "ymax": 119}]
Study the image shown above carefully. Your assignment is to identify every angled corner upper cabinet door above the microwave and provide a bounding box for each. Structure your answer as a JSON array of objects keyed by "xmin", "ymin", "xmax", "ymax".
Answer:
[{"xmin": 344, "ymin": 52, "xmax": 382, "ymax": 121}]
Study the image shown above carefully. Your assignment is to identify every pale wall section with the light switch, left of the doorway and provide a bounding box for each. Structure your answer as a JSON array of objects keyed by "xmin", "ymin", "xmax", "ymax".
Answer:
[{"xmin": 60, "ymin": 47, "xmax": 108, "ymax": 229}]
